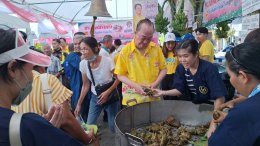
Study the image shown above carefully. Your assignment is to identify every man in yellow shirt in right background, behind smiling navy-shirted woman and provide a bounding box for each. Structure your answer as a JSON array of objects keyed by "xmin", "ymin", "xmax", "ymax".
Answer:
[{"xmin": 195, "ymin": 27, "xmax": 214, "ymax": 63}]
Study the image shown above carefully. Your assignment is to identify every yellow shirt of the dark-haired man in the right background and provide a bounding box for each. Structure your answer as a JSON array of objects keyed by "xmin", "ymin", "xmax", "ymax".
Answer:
[{"xmin": 200, "ymin": 40, "xmax": 214, "ymax": 63}]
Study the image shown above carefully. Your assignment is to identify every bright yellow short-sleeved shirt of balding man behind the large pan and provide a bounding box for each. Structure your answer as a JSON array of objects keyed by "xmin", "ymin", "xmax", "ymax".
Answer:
[{"xmin": 115, "ymin": 40, "xmax": 166, "ymax": 106}]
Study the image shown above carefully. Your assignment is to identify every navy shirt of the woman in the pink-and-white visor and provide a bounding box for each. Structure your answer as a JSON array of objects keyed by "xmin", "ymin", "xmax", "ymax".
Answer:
[{"xmin": 0, "ymin": 107, "xmax": 82, "ymax": 146}]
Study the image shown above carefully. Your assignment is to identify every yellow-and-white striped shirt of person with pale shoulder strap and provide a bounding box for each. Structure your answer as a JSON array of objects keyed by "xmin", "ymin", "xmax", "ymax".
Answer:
[{"xmin": 12, "ymin": 71, "xmax": 72, "ymax": 115}]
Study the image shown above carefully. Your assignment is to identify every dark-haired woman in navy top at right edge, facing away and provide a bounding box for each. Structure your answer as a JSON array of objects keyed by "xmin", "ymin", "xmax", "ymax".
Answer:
[{"xmin": 209, "ymin": 42, "xmax": 260, "ymax": 146}]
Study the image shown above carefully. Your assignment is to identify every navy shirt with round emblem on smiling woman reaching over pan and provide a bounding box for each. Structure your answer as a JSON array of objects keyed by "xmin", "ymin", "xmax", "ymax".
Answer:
[{"xmin": 173, "ymin": 59, "xmax": 227, "ymax": 103}]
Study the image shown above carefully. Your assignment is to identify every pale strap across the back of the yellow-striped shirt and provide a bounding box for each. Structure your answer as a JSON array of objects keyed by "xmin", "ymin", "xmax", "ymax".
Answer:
[{"xmin": 40, "ymin": 73, "xmax": 52, "ymax": 110}]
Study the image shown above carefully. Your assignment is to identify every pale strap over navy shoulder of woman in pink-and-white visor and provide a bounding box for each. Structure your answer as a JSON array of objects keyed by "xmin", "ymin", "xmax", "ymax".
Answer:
[{"xmin": 9, "ymin": 113, "xmax": 23, "ymax": 146}]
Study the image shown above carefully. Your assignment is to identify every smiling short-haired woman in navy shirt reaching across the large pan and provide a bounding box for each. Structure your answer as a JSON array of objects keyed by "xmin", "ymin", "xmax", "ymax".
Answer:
[{"xmin": 156, "ymin": 39, "xmax": 227, "ymax": 137}]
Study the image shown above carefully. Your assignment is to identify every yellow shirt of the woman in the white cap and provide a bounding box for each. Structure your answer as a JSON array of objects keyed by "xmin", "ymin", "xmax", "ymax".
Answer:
[{"xmin": 165, "ymin": 52, "xmax": 179, "ymax": 75}]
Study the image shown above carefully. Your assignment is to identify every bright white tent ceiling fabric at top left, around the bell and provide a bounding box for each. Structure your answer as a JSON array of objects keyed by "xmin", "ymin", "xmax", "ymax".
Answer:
[{"xmin": 0, "ymin": 0, "xmax": 133, "ymax": 23}]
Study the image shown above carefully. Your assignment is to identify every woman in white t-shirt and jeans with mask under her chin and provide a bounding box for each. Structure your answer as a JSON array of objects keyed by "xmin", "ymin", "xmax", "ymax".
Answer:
[{"xmin": 74, "ymin": 37, "xmax": 119, "ymax": 132}]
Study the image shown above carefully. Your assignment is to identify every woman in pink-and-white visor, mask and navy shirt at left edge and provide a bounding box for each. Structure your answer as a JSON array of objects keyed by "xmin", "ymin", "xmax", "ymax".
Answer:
[{"xmin": 0, "ymin": 29, "xmax": 81, "ymax": 146}]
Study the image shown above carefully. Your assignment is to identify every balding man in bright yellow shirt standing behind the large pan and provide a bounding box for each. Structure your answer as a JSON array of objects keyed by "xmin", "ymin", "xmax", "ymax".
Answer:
[{"xmin": 115, "ymin": 19, "xmax": 166, "ymax": 106}]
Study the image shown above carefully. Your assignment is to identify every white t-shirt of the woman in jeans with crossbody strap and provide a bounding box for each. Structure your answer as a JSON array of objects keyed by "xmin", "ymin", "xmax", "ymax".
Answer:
[{"xmin": 79, "ymin": 56, "xmax": 115, "ymax": 95}]
